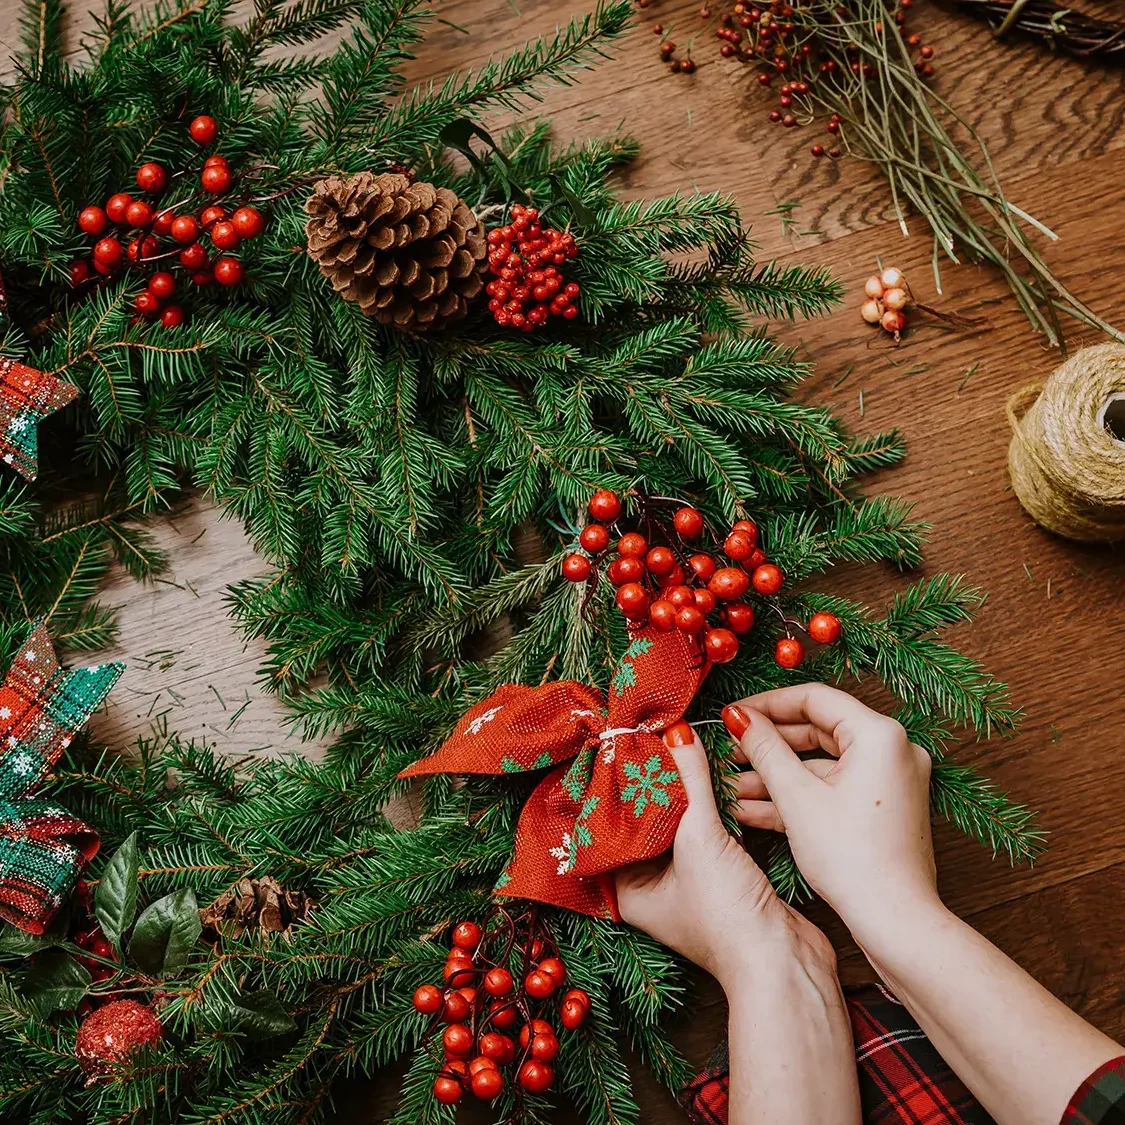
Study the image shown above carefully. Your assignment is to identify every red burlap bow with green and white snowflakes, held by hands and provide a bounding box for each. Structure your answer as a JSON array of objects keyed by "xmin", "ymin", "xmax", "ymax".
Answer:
[{"xmin": 399, "ymin": 629, "xmax": 709, "ymax": 918}]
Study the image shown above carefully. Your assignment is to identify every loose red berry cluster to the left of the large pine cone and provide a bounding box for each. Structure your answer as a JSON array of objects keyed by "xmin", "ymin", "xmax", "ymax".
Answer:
[{"xmin": 70, "ymin": 117, "xmax": 266, "ymax": 329}]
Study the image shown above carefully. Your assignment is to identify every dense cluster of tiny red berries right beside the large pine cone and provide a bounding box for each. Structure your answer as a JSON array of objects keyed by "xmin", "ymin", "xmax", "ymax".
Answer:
[{"xmin": 486, "ymin": 204, "xmax": 581, "ymax": 332}]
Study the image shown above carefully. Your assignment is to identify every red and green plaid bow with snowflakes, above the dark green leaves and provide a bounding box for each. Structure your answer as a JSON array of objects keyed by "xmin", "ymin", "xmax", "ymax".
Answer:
[{"xmin": 0, "ymin": 624, "xmax": 125, "ymax": 934}]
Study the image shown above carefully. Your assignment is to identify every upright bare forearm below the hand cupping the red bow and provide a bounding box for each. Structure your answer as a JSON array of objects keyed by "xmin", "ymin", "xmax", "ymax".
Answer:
[{"xmin": 727, "ymin": 951, "xmax": 861, "ymax": 1125}]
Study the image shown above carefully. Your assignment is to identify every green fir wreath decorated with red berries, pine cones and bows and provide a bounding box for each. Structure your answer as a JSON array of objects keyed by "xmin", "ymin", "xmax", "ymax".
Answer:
[{"xmin": 0, "ymin": 0, "xmax": 1038, "ymax": 1125}]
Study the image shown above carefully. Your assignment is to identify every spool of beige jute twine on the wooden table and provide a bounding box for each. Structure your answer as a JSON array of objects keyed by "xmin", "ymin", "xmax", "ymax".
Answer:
[{"xmin": 1007, "ymin": 343, "xmax": 1125, "ymax": 542}]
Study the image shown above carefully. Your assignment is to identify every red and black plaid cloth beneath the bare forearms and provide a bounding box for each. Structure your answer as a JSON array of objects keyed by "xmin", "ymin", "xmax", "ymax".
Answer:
[{"xmin": 678, "ymin": 984, "xmax": 994, "ymax": 1125}]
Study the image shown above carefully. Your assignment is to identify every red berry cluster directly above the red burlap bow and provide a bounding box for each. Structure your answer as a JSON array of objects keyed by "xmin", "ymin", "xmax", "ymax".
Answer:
[{"xmin": 563, "ymin": 488, "xmax": 840, "ymax": 668}]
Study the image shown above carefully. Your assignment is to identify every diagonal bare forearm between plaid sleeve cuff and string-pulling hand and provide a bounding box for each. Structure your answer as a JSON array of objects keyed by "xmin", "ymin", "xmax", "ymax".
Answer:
[{"xmin": 845, "ymin": 898, "xmax": 1123, "ymax": 1125}]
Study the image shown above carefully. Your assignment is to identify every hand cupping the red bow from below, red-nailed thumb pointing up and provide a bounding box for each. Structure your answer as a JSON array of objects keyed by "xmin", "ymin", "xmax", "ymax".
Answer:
[{"xmin": 617, "ymin": 722, "xmax": 836, "ymax": 995}]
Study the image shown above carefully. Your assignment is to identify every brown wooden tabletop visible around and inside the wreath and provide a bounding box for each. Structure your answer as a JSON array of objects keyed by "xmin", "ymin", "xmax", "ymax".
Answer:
[{"xmin": 0, "ymin": 0, "xmax": 1125, "ymax": 1123}]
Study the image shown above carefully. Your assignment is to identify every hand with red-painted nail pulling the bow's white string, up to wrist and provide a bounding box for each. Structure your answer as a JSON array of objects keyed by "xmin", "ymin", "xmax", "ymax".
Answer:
[{"xmin": 722, "ymin": 684, "xmax": 938, "ymax": 933}]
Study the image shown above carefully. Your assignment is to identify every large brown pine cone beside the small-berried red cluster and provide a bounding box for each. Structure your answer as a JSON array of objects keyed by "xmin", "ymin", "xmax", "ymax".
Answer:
[{"xmin": 305, "ymin": 172, "xmax": 487, "ymax": 331}]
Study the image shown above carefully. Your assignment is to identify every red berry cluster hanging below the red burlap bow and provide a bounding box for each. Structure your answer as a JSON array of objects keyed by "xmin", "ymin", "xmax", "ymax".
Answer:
[{"xmin": 414, "ymin": 908, "xmax": 590, "ymax": 1105}]
